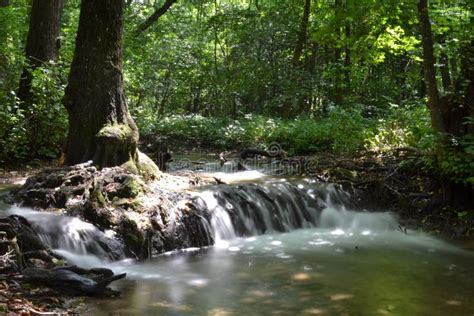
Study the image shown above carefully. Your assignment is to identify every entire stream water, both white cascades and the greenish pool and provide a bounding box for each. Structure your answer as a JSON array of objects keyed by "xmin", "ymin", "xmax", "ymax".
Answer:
[{"xmin": 1, "ymin": 177, "xmax": 474, "ymax": 316}]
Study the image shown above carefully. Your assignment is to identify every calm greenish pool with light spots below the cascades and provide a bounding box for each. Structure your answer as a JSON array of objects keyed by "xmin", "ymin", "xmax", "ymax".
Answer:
[{"xmin": 86, "ymin": 222, "xmax": 474, "ymax": 315}]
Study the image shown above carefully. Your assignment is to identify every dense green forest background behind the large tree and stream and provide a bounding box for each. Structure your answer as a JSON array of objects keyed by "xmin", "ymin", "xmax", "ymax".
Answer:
[{"xmin": 0, "ymin": 0, "xmax": 474, "ymax": 186}]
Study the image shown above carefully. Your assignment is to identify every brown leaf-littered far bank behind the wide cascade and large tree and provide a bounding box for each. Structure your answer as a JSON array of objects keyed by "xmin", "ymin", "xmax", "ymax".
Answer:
[{"xmin": 0, "ymin": 147, "xmax": 474, "ymax": 239}]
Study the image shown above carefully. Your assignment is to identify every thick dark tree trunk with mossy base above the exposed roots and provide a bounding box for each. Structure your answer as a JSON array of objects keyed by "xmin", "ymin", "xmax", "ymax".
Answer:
[{"xmin": 64, "ymin": 0, "xmax": 157, "ymax": 178}]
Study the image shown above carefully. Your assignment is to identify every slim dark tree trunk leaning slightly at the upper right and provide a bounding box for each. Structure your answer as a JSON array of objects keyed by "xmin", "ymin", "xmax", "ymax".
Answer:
[{"xmin": 418, "ymin": 0, "xmax": 446, "ymax": 133}]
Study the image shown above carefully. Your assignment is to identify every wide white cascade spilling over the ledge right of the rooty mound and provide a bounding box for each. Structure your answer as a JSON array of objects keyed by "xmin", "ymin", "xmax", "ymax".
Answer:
[{"xmin": 191, "ymin": 179, "xmax": 380, "ymax": 243}]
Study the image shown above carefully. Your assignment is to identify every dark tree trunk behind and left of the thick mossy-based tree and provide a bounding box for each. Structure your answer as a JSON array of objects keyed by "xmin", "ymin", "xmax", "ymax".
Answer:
[{"xmin": 17, "ymin": 0, "xmax": 63, "ymax": 154}]
